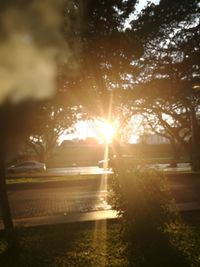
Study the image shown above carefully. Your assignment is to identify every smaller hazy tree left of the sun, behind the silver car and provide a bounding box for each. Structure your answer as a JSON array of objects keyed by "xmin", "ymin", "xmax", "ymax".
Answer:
[{"xmin": 26, "ymin": 99, "xmax": 76, "ymax": 162}]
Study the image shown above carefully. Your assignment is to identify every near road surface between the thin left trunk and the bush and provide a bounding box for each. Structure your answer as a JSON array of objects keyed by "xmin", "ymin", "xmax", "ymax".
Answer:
[{"xmin": 3, "ymin": 176, "xmax": 111, "ymax": 218}]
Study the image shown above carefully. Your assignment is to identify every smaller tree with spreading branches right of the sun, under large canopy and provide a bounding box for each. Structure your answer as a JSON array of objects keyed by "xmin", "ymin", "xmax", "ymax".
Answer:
[{"xmin": 132, "ymin": 89, "xmax": 191, "ymax": 160}]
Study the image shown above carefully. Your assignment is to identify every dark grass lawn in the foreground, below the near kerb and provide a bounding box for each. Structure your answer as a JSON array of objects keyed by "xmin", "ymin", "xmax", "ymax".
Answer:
[{"xmin": 0, "ymin": 212, "xmax": 200, "ymax": 267}]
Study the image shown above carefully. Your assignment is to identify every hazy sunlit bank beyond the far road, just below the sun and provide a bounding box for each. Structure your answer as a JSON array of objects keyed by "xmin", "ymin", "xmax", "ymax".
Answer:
[{"xmin": 47, "ymin": 144, "xmax": 187, "ymax": 167}]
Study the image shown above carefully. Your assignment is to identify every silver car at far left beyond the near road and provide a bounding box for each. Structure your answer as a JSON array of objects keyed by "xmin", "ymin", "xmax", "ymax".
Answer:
[{"xmin": 6, "ymin": 161, "xmax": 46, "ymax": 173}]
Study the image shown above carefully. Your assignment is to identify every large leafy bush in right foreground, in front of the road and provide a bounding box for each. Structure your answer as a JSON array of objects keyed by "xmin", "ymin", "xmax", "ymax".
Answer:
[{"xmin": 111, "ymin": 168, "xmax": 199, "ymax": 267}]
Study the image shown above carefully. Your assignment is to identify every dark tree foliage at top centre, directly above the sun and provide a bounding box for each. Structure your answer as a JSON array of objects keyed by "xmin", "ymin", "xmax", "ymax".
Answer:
[{"xmin": 59, "ymin": 0, "xmax": 141, "ymax": 118}]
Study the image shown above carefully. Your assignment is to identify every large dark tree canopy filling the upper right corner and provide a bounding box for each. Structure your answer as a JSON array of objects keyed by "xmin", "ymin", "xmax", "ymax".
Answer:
[{"xmin": 112, "ymin": 0, "xmax": 200, "ymax": 170}]
